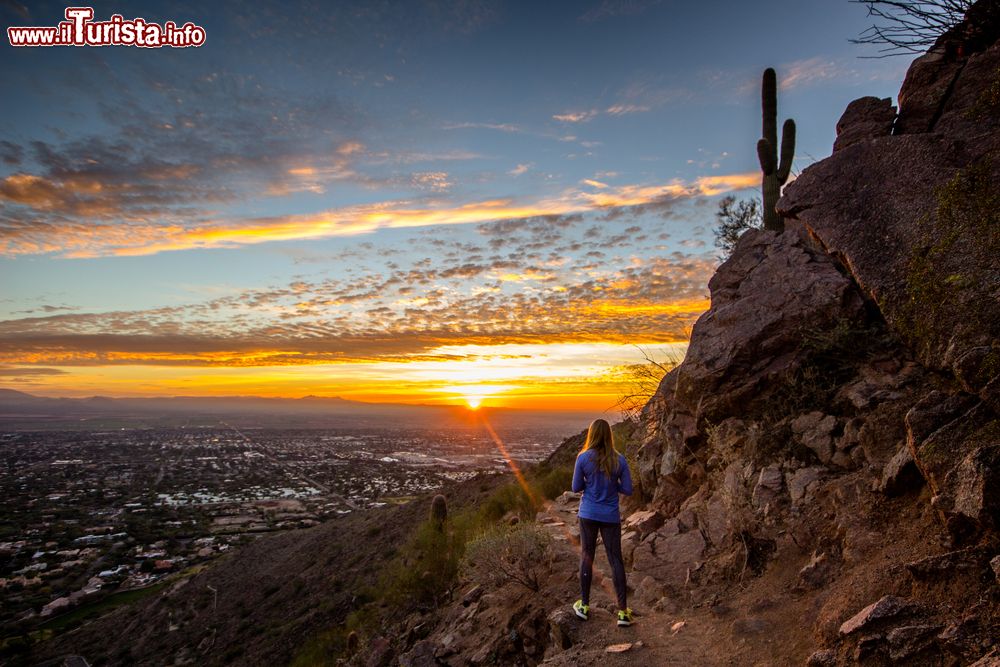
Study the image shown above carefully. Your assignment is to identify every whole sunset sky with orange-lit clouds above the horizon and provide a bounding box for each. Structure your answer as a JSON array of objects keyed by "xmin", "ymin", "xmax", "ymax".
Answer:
[{"xmin": 0, "ymin": 0, "xmax": 908, "ymax": 410}]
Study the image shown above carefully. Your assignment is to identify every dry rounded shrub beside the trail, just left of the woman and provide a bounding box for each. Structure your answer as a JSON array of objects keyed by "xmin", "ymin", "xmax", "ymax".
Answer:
[{"xmin": 462, "ymin": 523, "xmax": 552, "ymax": 591}]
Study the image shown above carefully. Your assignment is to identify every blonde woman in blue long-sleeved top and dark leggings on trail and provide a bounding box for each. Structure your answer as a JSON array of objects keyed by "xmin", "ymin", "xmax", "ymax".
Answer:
[{"xmin": 573, "ymin": 419, "xmax": 632, "ymax": 626}]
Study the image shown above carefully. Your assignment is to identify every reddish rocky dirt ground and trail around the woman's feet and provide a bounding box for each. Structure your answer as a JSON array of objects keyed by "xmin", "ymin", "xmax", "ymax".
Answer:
[{"xmin": 396, "ymin": 440, "xmax": 1000, "ymax": 666}]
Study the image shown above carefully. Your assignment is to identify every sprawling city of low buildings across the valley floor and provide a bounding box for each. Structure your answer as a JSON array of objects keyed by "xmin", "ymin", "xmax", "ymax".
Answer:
[{"xmin": 0, "ymin": 395, "xmax": 586, "ymax": 639}]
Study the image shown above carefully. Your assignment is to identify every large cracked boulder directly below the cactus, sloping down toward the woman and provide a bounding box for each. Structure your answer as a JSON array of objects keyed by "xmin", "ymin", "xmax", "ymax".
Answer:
[{"xmin": 639, "ymin": 226, "xmax": 866, "ymax": 516}]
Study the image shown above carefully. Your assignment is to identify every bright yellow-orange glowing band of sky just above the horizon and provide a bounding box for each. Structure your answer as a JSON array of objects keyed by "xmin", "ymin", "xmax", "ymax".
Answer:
[{"xmin": 0, "ymin": 339, "xmax": 684, "ymax": 411}]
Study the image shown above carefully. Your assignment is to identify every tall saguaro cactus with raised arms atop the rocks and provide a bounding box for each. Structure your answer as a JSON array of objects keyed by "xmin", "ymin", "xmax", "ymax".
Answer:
[{"xmin": 757, "ymin": 67, "xmax": 795, "ymax": 232}]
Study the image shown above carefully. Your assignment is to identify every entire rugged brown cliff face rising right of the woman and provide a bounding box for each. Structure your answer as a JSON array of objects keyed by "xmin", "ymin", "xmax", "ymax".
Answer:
[{"xmin": 633, "ymin": 2, "xmax": 1000, "ymax": 664}]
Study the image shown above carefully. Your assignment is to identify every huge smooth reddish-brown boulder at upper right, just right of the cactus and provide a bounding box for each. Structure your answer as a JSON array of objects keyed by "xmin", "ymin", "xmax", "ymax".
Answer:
[{"xmin": 778, "ymin": 20, "xmax": 1000, "ymax": 398}]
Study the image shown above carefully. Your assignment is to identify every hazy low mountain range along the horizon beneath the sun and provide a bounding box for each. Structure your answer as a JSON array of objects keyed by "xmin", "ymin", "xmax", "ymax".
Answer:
[{"xmin": 0, "ymin": 389, "xmax": 600, "ymax": 436}]
